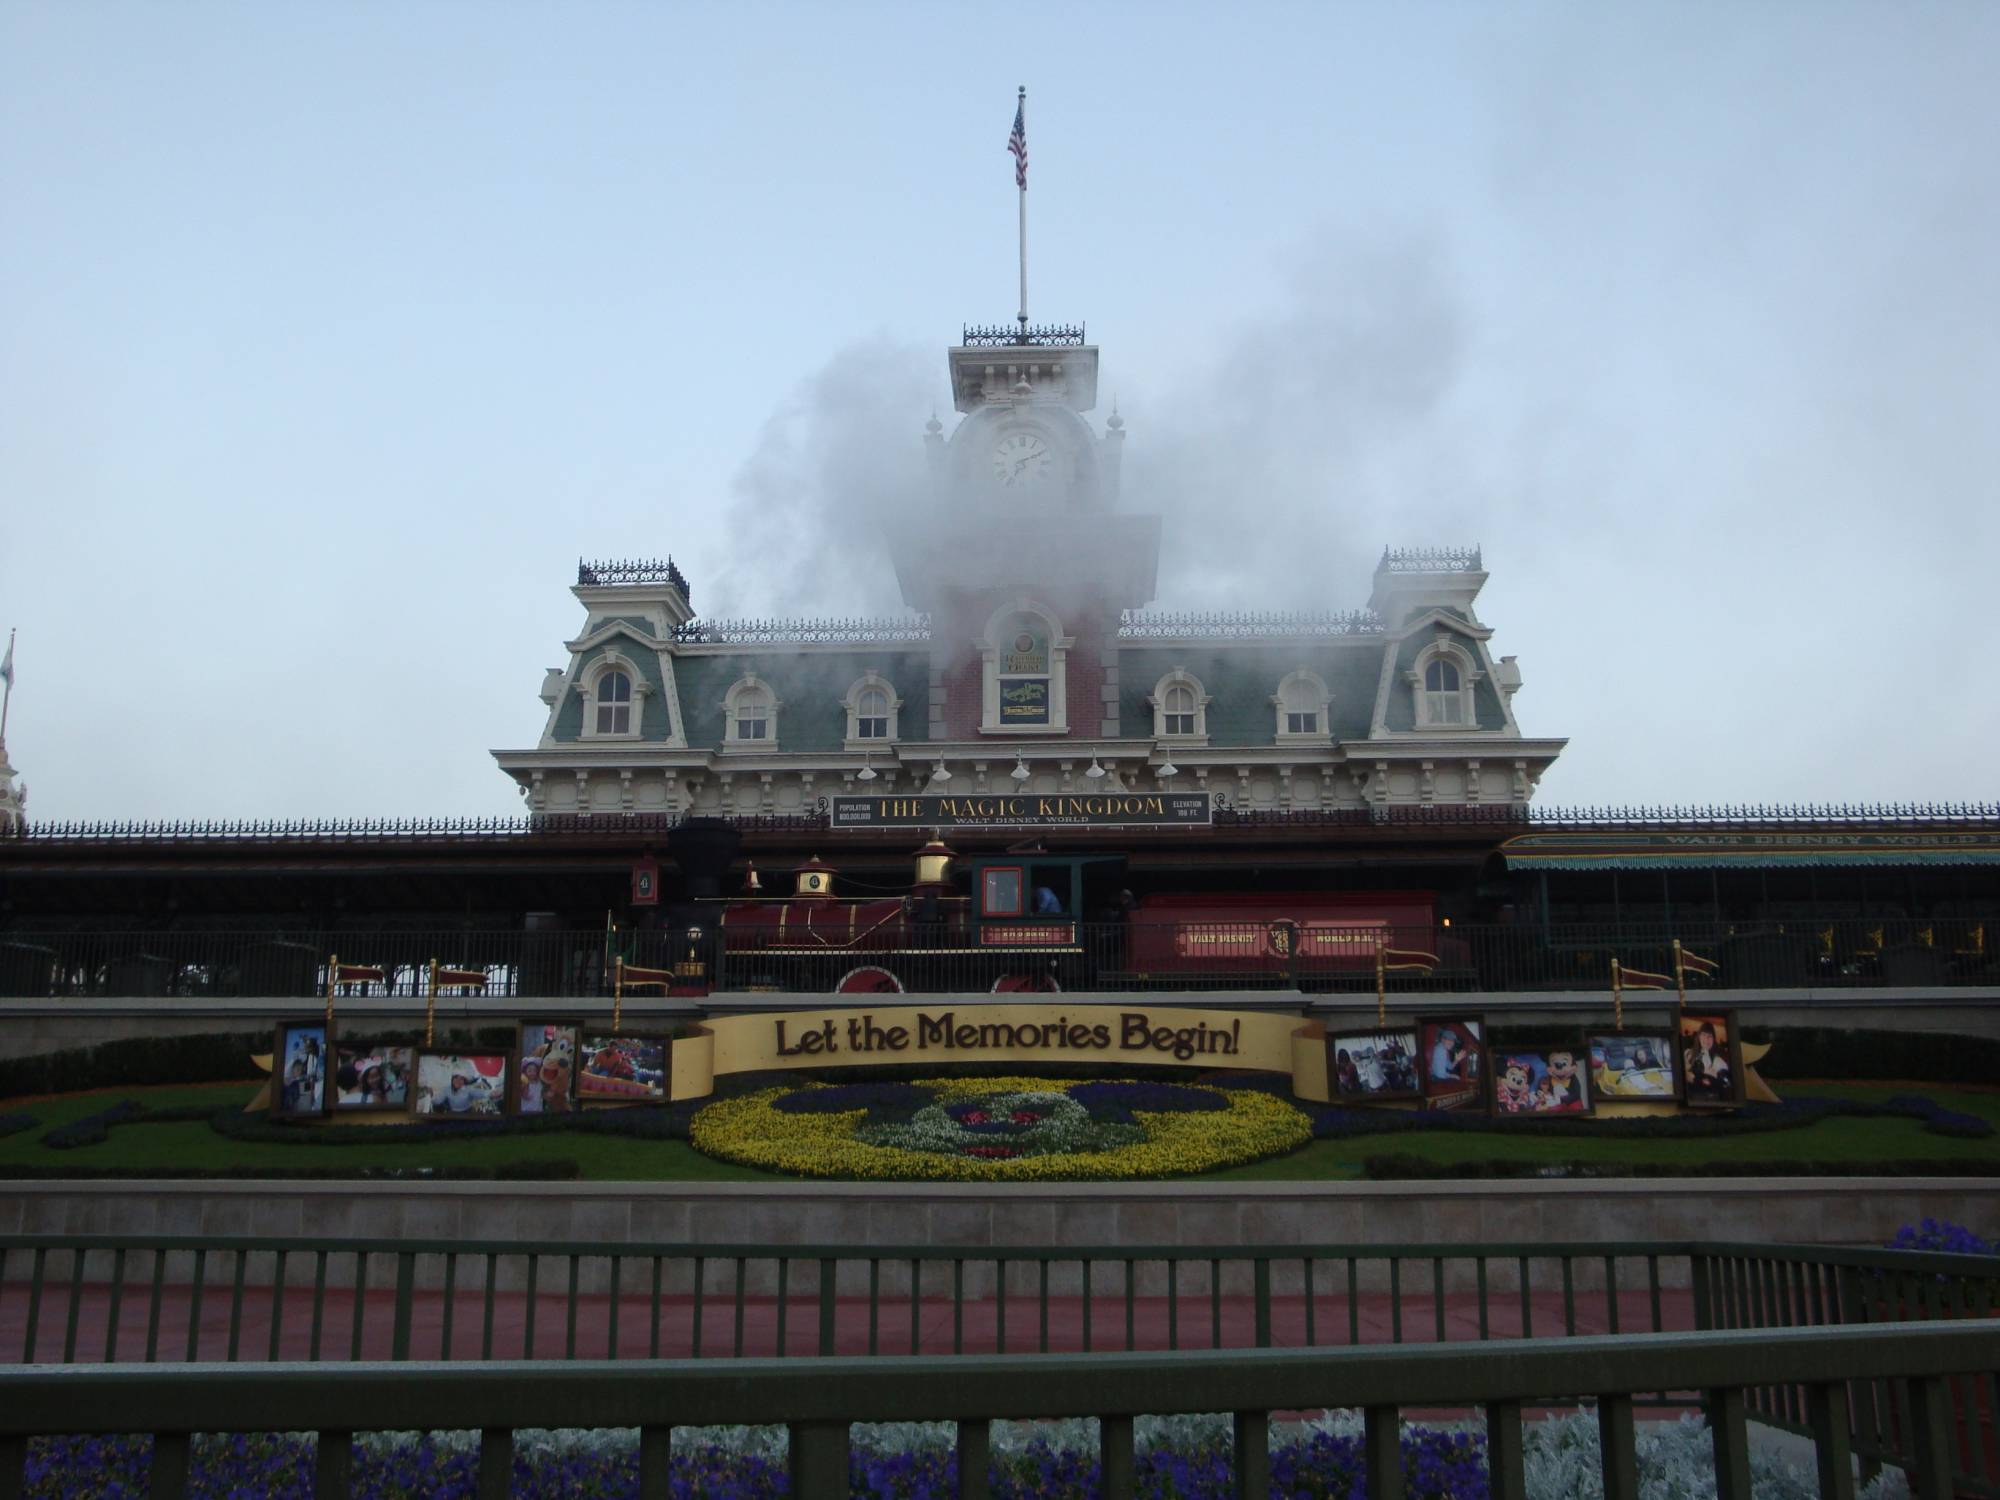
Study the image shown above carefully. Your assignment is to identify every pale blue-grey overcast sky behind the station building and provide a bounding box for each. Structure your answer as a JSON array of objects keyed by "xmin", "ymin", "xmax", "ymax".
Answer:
[{"xmin": 0, "ymin": 0, "xmax": 2000, "ymax": 818}]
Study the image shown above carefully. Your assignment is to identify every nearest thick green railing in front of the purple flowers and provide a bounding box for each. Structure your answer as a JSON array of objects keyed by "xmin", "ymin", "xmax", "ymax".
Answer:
[{"xmin": 0, "ymin": 1322, "xmax": 2000, "ymax": 1500}]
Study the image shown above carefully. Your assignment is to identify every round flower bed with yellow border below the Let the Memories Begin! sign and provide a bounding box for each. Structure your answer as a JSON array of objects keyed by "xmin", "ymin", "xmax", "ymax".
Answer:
[{"xmin": 690, "ymin": 1078, "xmax": 1312, "ymax": 1182}]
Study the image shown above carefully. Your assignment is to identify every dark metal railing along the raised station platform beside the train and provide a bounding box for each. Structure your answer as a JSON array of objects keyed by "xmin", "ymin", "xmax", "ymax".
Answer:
[{"xmin": 0, "ymin": 912, "xmax": 2000, "ymax": 998}]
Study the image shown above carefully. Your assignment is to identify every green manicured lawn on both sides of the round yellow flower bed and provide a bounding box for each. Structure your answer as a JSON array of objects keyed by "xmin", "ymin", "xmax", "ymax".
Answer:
[{"xmin": 0, "ymin": 1084, "xmax": 2000, "ymax": 1182}]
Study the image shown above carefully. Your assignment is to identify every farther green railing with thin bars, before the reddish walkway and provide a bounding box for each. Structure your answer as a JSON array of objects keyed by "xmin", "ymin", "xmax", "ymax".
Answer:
[{"xmin": 0, "ymin": 1236, "xmax": 2000, "ymax": 1364}]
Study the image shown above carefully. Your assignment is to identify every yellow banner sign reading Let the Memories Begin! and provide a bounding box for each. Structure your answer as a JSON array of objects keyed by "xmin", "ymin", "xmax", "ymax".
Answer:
[{"xmin": 672, "ymin": 1004, "xmax": 1328, "ymax": 1100}]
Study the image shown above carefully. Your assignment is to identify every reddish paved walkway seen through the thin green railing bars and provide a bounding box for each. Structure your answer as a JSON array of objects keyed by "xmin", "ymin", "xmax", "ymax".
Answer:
[{"xmin": 0, "ymin": 1278, "xmax": 1694, "ymax": 1364}]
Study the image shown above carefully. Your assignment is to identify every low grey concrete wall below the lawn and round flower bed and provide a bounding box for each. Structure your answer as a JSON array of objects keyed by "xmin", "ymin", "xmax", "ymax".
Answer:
[{"xmin": 0, "ymin": 1178, "xmax": 2000, "ymax": 1294}]
